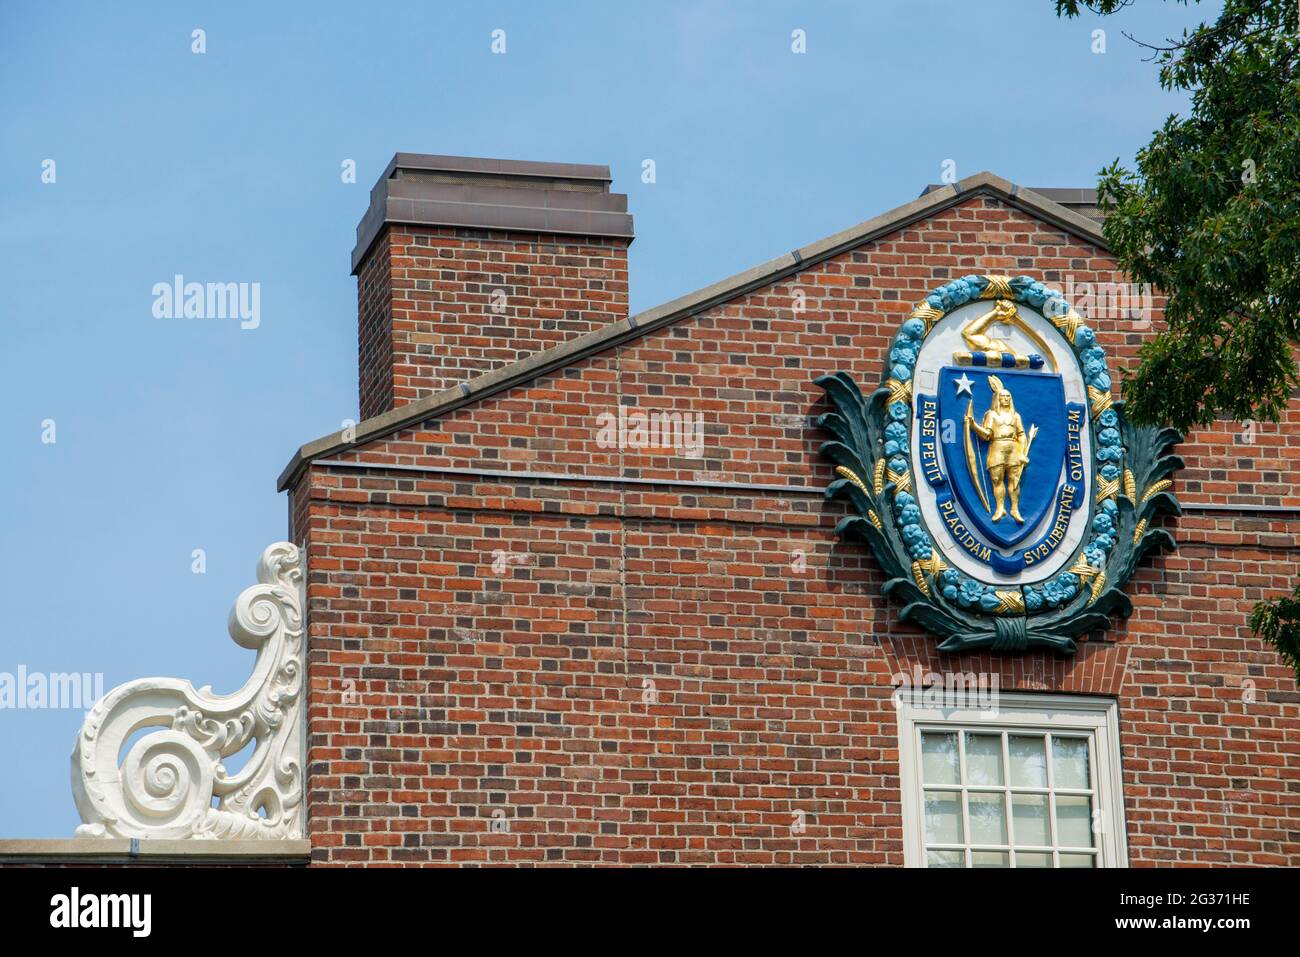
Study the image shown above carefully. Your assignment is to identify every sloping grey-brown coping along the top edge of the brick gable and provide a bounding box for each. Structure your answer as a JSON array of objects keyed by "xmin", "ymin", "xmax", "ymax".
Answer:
[{"xmin": 277, "ymin": 170, "xmax": 1110, "ymax": 490}]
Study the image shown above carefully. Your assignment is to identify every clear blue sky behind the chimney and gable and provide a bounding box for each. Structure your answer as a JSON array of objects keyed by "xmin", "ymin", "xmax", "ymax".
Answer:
[{"xmin": 0, "ymin": 0, "xmax": 1214, "ymax": 837}]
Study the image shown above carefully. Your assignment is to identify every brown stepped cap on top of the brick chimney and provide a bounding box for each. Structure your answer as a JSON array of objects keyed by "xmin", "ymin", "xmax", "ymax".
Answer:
[{"xmin": 352, "ymin": 153, "xmax": 634, "ymax": 273}]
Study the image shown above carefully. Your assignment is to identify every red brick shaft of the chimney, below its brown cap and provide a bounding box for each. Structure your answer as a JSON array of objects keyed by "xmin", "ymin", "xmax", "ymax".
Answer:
[{"xmin": 358, "ymin": 226, "xmax": 628, "ymax": 419}]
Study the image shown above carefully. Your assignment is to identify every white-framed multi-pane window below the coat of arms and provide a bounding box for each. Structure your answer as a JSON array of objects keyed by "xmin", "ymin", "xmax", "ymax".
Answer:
[{"xmin": 894, "ymin": 688, "xmax": 1128, "ymax": 867}]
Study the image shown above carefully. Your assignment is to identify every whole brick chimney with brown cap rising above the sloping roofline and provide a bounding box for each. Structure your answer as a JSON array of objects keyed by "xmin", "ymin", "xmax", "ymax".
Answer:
[{"xmin": 352, "ymin": 153, "xmax": 633, "ymax": 419}]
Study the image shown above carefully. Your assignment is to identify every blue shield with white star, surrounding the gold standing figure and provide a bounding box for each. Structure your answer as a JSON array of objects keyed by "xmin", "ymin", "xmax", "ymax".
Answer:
[{"xmin": 939, "ymin": 365, "xmax": 1066, "ymax": 549}]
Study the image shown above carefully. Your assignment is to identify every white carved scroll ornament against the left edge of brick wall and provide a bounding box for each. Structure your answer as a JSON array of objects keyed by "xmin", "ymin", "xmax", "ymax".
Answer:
[{"xmin": 73, "ymin": 542, "xmax": 306, "ymax": 840}]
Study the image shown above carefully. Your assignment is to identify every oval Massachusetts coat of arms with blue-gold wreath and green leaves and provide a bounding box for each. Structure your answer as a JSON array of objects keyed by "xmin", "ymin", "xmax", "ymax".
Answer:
[{"xmin": 816, "ymin": 276, "xmax": 1183, "ymax": 653}]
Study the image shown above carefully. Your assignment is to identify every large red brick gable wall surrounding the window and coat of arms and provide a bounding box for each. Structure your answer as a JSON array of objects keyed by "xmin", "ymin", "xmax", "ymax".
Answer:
[{"xmin": 294, "ymin": 199, "xmax": 1300, "ymax": 866}]
